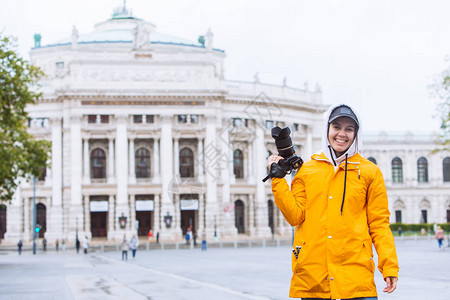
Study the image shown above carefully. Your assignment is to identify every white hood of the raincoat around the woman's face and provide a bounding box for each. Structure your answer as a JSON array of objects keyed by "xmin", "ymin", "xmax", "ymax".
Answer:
[{"xmin": 321, "ymin": 104, "xmax": 362, "ymax": 168}]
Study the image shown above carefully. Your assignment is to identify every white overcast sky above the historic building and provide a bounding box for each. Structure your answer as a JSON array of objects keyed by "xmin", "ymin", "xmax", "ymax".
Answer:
[{"xmin": 0, "ymin": 0, "xmax": 450, "ymax": 131}]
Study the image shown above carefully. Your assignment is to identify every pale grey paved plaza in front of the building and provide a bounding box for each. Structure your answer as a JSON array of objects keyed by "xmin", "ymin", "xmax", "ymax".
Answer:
[{"xmin": 0, "ymin": 239, "xmax": 450, "ymax": 300}]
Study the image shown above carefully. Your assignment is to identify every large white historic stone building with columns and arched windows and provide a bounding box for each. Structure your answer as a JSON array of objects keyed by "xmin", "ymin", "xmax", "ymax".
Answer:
[{"xmin": 0, "ymin": 8, "xmax": 450, "ymax": 242}]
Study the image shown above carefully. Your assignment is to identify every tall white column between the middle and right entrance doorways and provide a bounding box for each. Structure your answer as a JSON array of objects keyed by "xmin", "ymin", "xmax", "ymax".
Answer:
[{"xmin": 160, "ymin": 116, "xmax": 175, "ymax": 240}]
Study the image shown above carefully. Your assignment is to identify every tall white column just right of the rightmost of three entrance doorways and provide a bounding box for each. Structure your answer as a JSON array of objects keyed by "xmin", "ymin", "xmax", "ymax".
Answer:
[{"xmin": 205, "ymin": 116, "xmax": 220, "ymax": 239}]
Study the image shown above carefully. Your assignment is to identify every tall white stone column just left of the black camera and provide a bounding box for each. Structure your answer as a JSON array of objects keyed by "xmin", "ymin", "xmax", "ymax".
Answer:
[{"xmin": 253, "ymin": 126, "xmax": 272, "ymax": 237}]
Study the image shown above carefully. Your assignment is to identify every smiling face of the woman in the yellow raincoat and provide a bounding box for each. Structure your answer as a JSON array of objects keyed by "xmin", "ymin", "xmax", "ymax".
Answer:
[{"xmin": 328, "ymin": 117, "xmax": 357, "ymax": 157}]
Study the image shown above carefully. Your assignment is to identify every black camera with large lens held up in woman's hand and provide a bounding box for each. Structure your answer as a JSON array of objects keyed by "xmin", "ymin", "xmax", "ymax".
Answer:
[{"xmin": 263, "ymin": 126, "xmax": 303, "ymax": 182}]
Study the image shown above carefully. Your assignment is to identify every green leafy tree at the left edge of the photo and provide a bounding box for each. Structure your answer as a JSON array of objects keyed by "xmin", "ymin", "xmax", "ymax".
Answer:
[{"xmin": 0, "ymin": 33, "xmax": 50, "ymax": 201}]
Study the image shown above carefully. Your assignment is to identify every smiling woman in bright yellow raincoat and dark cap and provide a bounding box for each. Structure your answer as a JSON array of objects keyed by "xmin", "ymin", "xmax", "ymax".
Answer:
[{"xmin": 268, "ymin": 105, "xmax": 399, "ymax": 299}]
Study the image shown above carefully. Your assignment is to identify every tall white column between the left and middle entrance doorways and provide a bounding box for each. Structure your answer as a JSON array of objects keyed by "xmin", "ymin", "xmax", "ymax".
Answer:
[{"xmin": 115, "ymin": 115, "xmax": 130, "ymax": 241}]
